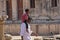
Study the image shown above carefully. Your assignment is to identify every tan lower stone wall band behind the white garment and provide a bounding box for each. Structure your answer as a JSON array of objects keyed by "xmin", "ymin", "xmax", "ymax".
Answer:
[{"xmin": 4, "ymin": 24, "xmax": 60, "ymax": 35}]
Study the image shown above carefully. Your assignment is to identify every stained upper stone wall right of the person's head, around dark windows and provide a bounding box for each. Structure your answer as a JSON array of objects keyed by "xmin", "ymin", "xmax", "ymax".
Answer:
[{"xmin": 30, "ymin": 0, "xmax": 60, "ymax": 19}]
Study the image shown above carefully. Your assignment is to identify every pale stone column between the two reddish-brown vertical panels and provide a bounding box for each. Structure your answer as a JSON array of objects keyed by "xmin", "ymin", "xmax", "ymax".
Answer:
[{"xmin": 12, "ymin": 0, "xmax": 18, "ymax": 20}]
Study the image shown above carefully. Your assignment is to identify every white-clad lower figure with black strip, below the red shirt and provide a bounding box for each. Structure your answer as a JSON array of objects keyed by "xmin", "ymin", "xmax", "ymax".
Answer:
[{"xmin": 21, "ymin": 18, "xmax": 37, "ymax": 40}]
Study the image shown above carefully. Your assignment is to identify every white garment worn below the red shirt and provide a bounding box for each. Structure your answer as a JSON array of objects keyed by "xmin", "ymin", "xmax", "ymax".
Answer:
[{"xmin": 20, "ymin": 23, "xmax": 32, "ymax": 40}]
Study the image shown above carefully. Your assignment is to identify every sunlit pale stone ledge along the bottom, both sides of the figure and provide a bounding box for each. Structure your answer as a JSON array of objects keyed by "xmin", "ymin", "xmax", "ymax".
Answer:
[{"xmin": 5, "ymin": 34, "xmax": 56, "ymax": 40}]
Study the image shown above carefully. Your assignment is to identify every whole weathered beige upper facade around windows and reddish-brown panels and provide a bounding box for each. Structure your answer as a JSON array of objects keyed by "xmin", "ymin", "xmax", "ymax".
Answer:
[{"xmin": 0, "ymin": 0, "xmax": 60, "ymax": 20}]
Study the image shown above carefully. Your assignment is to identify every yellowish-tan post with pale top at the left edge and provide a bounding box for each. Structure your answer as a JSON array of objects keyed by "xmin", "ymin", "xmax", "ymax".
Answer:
[{"xmin": 0, "ymin": 15, "xmax": 7, "ymax": 40}]
